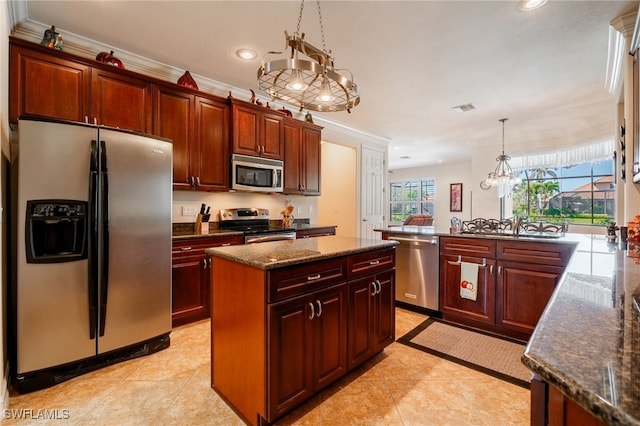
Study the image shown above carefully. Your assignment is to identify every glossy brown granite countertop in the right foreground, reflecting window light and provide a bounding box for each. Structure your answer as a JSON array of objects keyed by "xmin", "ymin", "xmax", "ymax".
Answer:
[{"xmin": 522, "ymin": 234, "xmax": 640, "ymax": 425}]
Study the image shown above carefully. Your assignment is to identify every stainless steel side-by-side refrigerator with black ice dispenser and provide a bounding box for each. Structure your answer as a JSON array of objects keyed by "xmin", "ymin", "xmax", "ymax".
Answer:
[{"xmin": 11, "ymin": 119, "xmax": 172, "ymax": 392}]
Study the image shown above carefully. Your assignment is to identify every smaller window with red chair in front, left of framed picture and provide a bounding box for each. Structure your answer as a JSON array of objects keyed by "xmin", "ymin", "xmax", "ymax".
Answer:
[{"xmin": 389, "ymin": 179, "xmax": 436, "ymax": 224}]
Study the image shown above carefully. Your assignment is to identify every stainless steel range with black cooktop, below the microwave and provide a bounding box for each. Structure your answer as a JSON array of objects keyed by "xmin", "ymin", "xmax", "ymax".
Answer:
[{"xmin": 218, "ymin": 208, "xmax": 296, "ymax": 244}]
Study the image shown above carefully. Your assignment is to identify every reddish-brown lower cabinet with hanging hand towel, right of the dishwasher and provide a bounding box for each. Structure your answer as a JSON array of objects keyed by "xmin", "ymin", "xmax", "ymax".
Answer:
[{"xmin": 440, "ymin": 237, "xmax": 575, "ymax": 341}]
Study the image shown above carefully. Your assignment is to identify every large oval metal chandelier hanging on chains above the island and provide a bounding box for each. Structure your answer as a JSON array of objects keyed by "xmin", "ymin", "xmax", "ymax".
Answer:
[{"xmin": 258, "ymin": 0, "xmax": 360, "ymax": 112}]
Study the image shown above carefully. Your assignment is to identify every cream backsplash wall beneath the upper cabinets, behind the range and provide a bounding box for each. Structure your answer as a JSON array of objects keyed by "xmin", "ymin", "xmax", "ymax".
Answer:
[{"xmin": 172, "ymin": 191, "xmax": 318, "ymax": 223}]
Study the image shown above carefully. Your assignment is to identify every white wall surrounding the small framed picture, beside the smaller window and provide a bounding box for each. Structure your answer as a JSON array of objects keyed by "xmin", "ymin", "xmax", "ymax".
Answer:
[{"xmin": 388, "ymin": 164, "xmax": 472, "ymax": 232}]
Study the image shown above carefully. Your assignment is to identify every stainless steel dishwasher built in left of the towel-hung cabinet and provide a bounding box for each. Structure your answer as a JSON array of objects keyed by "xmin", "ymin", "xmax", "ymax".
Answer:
[{"xmin": 387, "ymin": 234, "xmax": 440, "ymax": 311}]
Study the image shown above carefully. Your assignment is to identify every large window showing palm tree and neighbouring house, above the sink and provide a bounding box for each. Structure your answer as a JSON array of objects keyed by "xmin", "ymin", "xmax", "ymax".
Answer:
[{"xmin": 513, "ymin": 160, "xmax": 615, "ymax": 225}]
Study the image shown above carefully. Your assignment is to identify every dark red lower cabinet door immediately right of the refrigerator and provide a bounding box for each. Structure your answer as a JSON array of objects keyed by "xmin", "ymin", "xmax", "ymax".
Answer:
[{"xmin": 171, "ymin": 255, "xmax": 211, "ymax": 327}]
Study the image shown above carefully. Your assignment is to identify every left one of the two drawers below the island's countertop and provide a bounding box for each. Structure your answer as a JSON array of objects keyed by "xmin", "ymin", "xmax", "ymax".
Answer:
[{"xmin": 267, "ymin": 258, "xmax": 347, "ymax": 303}]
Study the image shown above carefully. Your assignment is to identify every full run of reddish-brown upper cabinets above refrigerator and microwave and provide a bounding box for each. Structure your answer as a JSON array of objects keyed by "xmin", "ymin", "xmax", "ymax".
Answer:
[{"xmin": 9, "ymin": 37, "xmax": 321, "ymax": 195}]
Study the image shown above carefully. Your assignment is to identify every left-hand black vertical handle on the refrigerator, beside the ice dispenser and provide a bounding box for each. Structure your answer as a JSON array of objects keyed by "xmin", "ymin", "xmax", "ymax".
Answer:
[{"xmin": 87, "ymin": 140, "xmax": 99, "ymax": 340}]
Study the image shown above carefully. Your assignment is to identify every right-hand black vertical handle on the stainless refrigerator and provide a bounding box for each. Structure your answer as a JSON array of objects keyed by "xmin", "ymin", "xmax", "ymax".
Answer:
[{"xmin": 99, "ymin": 140, "xmax": 109, "ymax": 336}]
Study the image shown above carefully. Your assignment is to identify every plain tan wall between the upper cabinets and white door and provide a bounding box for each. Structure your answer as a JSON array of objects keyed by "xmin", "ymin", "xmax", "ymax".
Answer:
[{"xmin": 318, "ymin": 142, "xmax": 358, "ymax": 237}]
